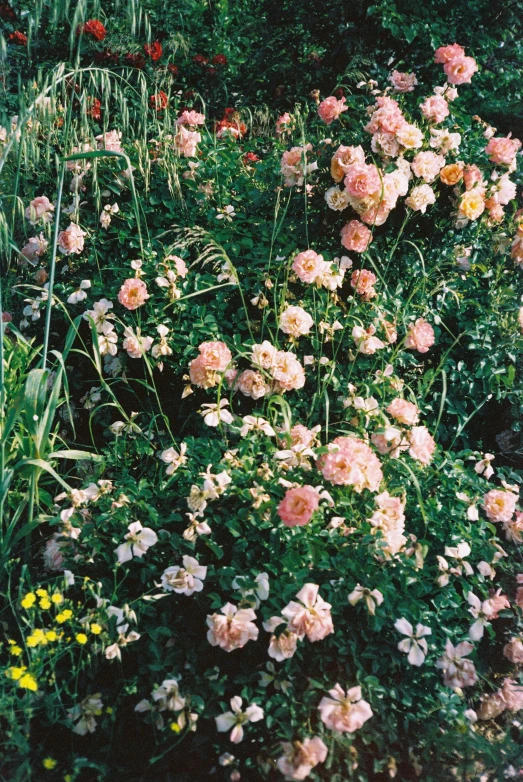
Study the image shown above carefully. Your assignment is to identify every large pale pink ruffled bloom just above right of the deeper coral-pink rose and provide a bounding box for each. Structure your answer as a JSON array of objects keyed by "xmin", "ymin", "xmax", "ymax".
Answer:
[{"xmin": 317, "ymin": 437, "xmax": 383, "ymax": 494}]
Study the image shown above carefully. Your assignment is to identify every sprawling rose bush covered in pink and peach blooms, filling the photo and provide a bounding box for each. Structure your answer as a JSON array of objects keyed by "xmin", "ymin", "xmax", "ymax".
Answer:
[{"xmin": 2, "ymin": 20, "xmax": 523, "ymax": 782}]
